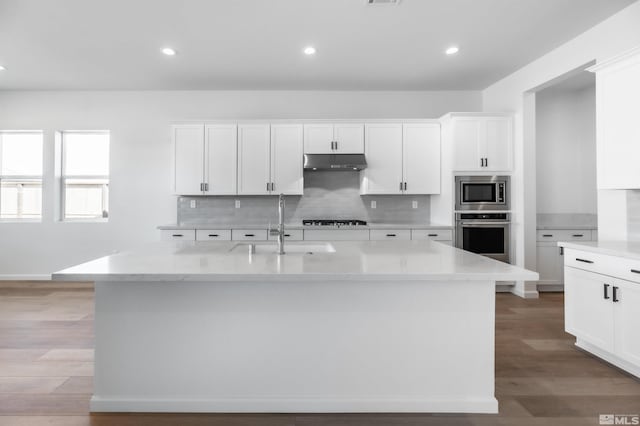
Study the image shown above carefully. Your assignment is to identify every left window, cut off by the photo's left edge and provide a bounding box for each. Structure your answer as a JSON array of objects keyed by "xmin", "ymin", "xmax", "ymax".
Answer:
[{"xmin": 0, "ymin": 132, "xmax": 43, "ymax": 220}]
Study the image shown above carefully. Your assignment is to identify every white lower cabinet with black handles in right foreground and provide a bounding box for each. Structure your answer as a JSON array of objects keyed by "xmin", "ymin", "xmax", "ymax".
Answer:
[{"xmin": 564, "ymin": 250, "xmax": 640, "ymax": 377}]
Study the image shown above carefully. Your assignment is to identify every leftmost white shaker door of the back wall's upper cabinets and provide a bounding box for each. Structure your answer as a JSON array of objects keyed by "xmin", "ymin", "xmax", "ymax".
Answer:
[{"xmin": 172, "ymin": 124, "xmax": 204, "ymax": 195}]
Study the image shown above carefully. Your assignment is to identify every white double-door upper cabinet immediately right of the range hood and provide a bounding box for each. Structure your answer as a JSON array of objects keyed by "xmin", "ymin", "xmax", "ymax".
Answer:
[{"xmin": 360, "ymin": 123, "xmax": 440, "ymax": 194}]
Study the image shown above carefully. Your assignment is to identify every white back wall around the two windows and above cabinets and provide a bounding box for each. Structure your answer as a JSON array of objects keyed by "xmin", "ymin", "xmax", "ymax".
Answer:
[{"xmin": 0, "ymin": 91, "xmax": 481, "ymax": 279}]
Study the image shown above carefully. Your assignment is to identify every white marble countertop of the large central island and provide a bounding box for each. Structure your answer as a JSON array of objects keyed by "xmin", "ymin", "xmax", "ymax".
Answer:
[{"xmin": 52, "ymin": 240, "xmax": 538, "ymax": 282}]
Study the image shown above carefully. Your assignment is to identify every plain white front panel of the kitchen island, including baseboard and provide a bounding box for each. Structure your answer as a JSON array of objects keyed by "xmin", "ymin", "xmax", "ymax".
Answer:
[{"xmin": 91, "ymin": 280, "xmax": 498, "ymax": 413}]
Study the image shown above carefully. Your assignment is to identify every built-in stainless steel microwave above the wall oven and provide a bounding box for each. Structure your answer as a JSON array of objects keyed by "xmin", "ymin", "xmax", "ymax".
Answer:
[{"xmin": 455, "ymin": 176, "xmax": 509, "ymax": 211}]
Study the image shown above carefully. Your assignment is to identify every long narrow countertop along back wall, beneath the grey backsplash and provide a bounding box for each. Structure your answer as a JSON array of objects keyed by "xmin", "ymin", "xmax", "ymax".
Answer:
[{"xmin": 158, "ymin": 223, "xmax": 453, "ymax": 231}]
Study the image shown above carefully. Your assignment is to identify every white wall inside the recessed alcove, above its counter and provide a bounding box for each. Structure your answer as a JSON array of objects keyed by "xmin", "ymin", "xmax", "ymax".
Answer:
[{"xmin": 536, "ymin": 83, "xmax": 597, "ymax": 214}]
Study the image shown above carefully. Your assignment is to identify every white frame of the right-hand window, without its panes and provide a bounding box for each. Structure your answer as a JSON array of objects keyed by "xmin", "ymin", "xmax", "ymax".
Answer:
[{"xmin": 59, "ymin": 130, "xmax": 111, "ymax": 223}]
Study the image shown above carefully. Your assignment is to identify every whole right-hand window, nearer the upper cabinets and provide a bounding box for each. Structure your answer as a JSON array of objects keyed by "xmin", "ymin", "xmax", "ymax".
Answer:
[{"xmin": 62, "ymin": 132, "xmax": 109, "ymax": 220}]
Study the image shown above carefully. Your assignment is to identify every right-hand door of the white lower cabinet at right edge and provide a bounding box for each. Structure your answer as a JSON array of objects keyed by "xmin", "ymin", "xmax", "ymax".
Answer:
[{"xmin": 614, "ymin": 280, "xmax": 640, "ymax": 366}]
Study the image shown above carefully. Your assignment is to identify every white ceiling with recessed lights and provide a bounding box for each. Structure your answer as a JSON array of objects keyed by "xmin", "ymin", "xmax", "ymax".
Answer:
[{"xmin": 0, "ymin": 0, "xmax": 633, "ymax": 90}]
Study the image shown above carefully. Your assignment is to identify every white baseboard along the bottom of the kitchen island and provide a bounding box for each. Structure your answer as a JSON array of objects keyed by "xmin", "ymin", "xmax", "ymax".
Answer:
[{"xmin": 91, "ymin": 396, "xmax": 498, "ymax": 414}]
